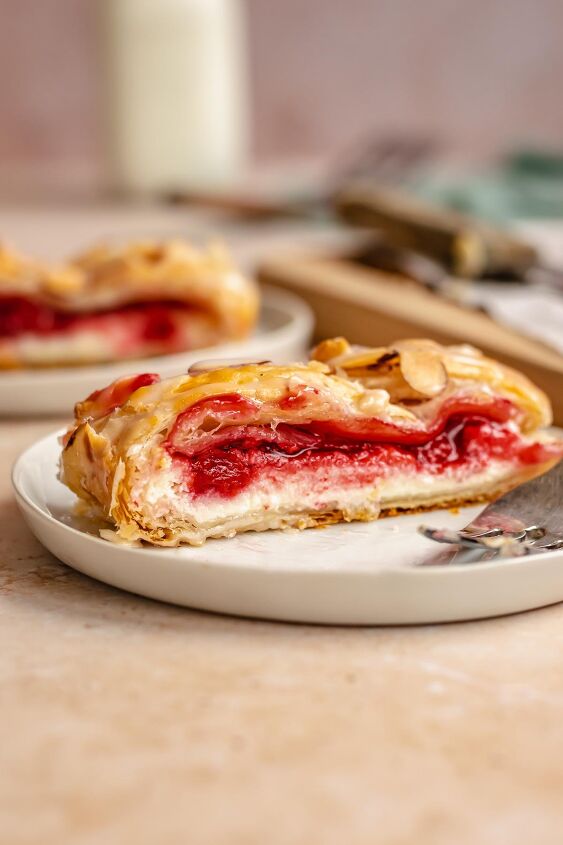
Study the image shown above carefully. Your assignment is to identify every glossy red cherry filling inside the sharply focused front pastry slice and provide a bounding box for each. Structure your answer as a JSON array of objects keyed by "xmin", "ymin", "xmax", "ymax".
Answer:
[{"xmin": 166, "ymin": 394, "xmax": 563, "ymax": 499}]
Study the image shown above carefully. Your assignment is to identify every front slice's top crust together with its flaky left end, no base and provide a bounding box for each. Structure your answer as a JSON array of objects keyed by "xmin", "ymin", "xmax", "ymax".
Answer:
[{"xmin": 61, "ymin": 338, "xmax": 551, "ymax": 538}]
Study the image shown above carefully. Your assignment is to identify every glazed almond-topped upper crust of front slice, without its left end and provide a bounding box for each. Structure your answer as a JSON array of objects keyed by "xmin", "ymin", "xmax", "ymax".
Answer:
[{"xmin": 66, "ymin": 338, "xmax": 551, "ymax": 448}]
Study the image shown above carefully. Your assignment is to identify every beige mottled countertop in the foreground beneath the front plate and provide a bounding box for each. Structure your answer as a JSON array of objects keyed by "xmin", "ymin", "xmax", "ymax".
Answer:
[{"xmin": 0, "ymin": 421, "xmax": 563, "ymax": 845}]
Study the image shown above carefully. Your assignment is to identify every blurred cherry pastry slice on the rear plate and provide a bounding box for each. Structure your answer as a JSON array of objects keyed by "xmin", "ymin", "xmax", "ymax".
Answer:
[{"xmin": 0, "ymin": 241, "xmax": 258, "ymax": 370}]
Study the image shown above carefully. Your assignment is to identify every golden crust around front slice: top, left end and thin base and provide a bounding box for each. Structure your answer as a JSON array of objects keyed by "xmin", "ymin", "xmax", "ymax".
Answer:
[{"xmin": 62, "ymin": 338, "xmax": 560, "ymax": 545}]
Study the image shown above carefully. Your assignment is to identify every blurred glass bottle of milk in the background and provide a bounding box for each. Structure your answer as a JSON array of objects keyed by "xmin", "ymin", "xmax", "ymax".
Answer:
[{"xmin": 102, "ymin": 0, "xmax": 248, "ymax": 192}]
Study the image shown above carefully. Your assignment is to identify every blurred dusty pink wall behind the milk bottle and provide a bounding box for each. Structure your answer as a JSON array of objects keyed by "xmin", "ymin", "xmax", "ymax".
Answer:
[{"xmin": 0, "ymin": 0, "xmax": 563, "ymax": 178}]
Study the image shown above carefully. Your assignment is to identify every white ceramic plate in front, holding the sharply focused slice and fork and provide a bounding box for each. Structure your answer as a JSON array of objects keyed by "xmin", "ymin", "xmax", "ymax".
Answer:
[{"xmin": 13, "ymin": 434, "xmax": 563, "ymax": 625}]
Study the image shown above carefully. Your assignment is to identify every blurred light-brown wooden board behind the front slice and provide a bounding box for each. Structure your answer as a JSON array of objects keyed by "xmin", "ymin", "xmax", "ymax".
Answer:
[{"xmin": 259, "ymin": 254, "xmax": 563, "ymax": 425}]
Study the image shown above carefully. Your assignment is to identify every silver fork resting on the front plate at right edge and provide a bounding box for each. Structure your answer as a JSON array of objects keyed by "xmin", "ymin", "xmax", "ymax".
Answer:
[{"xmin": 418, "ymin": 461, "xmax": 563, "ymax": 557}]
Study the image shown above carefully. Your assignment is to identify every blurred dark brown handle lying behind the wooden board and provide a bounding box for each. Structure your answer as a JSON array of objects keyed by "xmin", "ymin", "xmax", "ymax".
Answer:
[{"xmin": 335, "ymin": 187, "xmax": 538, "ymax": 279}]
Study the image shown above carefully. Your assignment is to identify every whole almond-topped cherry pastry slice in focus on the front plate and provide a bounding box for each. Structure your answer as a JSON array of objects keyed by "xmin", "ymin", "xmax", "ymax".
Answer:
[{"xmin": 61, "ymin": 339, "xmax": 563, "ymax": 546}]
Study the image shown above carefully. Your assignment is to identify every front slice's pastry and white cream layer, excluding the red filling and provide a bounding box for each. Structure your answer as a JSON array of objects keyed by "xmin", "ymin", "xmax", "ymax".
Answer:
[{"xmin": 61, "ymin": 338, "xmax": 563, "ymax": 545}]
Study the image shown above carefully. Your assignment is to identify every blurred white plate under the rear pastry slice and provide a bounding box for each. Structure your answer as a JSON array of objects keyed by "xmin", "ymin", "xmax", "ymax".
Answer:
[{"xmin": 0, "ymin": 287, "xmax": 313, "ymax": 416}]
